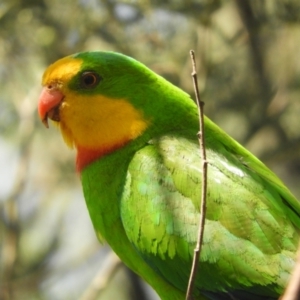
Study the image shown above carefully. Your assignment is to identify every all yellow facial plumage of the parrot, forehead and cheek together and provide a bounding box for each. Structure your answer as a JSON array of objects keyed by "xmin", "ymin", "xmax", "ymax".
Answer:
[{"xmin": 43, "ymin": 57, "xmax": 149, "ymax": 149}]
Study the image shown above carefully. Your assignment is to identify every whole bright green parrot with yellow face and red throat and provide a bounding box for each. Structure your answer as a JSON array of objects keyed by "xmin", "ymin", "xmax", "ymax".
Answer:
[{"xmin": 38, "ymin": 51, "xmax": 300, "ymax": 300}]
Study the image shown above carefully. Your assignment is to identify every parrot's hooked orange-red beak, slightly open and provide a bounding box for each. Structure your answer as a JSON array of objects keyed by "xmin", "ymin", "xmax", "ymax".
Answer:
[{"xmin": 38, "ymin": 86, "xmax": 64, "ymax": 128}]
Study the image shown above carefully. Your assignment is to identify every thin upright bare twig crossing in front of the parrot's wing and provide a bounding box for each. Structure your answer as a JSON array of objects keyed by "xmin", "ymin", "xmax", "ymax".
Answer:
[{"xmin": 186, "ymin": 50, "xmax": 207, "ymax": 300}]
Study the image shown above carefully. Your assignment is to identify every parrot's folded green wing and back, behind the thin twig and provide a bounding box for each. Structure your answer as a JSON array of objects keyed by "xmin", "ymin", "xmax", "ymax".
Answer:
[{"xmin": 121, "ymin": 128, "xmax": 300, "ymax": 299}]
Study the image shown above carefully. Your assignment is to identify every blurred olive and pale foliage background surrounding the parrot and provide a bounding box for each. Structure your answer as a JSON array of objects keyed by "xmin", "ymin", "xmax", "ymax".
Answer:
[{"xmin": 0, "ymin": 0, "xmax": 300, "ymax": 300}]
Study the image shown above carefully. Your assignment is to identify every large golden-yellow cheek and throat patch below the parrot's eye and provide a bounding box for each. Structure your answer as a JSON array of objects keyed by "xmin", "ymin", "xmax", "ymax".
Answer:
[{"xmin": 60, "ymin": 92, "xmax": 147, "ymax": 149}]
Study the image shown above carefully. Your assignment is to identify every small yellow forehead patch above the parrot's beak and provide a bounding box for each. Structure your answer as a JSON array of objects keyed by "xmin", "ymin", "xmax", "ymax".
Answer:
[{"xmin": 42, "ymin": 56, "xmax": 82, "ymax": 85}]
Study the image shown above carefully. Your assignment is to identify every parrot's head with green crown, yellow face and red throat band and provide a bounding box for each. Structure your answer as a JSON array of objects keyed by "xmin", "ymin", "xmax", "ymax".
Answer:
[{"xmin": 38, "ymin": 51, "xmax": 196, "ymax": 171}]
